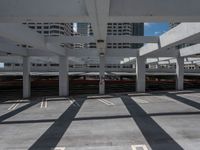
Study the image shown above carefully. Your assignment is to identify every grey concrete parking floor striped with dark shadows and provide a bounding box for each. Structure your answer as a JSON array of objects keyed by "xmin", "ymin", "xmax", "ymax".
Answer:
[{"xmin": 0, "ymin": 90, "xmax": 200, "ymax": 150}]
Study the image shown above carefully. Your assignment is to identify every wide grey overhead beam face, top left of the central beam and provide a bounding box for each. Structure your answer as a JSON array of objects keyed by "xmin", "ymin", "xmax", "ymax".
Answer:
[{"xmin": 0, "ymin": 0, "xmax": 88, "ymax": 23}]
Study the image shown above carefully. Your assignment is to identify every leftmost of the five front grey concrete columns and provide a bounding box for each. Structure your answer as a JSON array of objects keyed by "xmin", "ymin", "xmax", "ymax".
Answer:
[{"xmin": 23, "ymin": 56, "xmax": 31, "ymax": 98}]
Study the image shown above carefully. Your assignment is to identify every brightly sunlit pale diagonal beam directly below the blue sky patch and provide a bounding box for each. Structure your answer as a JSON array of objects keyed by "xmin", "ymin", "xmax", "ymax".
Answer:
[{"xmin": 140, "ymin": 23, "xmax": 200, "ymax": 56}]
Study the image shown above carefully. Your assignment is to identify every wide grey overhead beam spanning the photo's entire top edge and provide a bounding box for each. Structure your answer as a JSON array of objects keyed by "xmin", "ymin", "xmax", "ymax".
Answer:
[{"xmin": 0, "ymin": 0, "xmax": 200, "ymax": 23}]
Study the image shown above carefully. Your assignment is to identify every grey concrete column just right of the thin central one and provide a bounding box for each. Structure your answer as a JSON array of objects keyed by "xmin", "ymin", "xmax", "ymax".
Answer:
[{"xmin": 136, "ymin": 57, "xmax": 146, "ymax": 92}]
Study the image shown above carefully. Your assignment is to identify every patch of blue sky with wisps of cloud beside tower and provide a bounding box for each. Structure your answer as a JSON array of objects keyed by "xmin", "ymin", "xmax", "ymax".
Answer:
[{"xmin": 144, "ymin": 23, "xmax": 169, "ymax": 36}]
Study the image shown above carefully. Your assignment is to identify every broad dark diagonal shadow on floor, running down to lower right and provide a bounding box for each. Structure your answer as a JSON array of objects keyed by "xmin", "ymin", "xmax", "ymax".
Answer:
[{"xmin": 121, "ymin": 96, "xmax": 183, "ymax": 150}]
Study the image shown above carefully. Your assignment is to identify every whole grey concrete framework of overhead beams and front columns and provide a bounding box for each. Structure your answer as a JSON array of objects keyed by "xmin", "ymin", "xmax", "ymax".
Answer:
[{"xmin": 0, "ymin": 0, "xmax": 200, "ymax": 97}]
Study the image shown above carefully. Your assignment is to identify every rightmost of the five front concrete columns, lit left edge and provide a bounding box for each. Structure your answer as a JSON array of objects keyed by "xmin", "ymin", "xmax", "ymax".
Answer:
[{"xmin": 176, "ymin": 57, "xmax": 184, "ymax": 91}]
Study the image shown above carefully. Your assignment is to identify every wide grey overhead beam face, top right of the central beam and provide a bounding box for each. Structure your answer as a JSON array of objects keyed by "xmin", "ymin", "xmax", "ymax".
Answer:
[{"xmin": 110, "ymin": 0, "xmax": 200, "ymax": 22}]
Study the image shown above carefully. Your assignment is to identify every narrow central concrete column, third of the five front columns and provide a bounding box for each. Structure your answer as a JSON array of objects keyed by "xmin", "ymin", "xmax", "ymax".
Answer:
[{"xmin": 99, "ymin": 55, "xmax": 105, "ymax": 94}]
